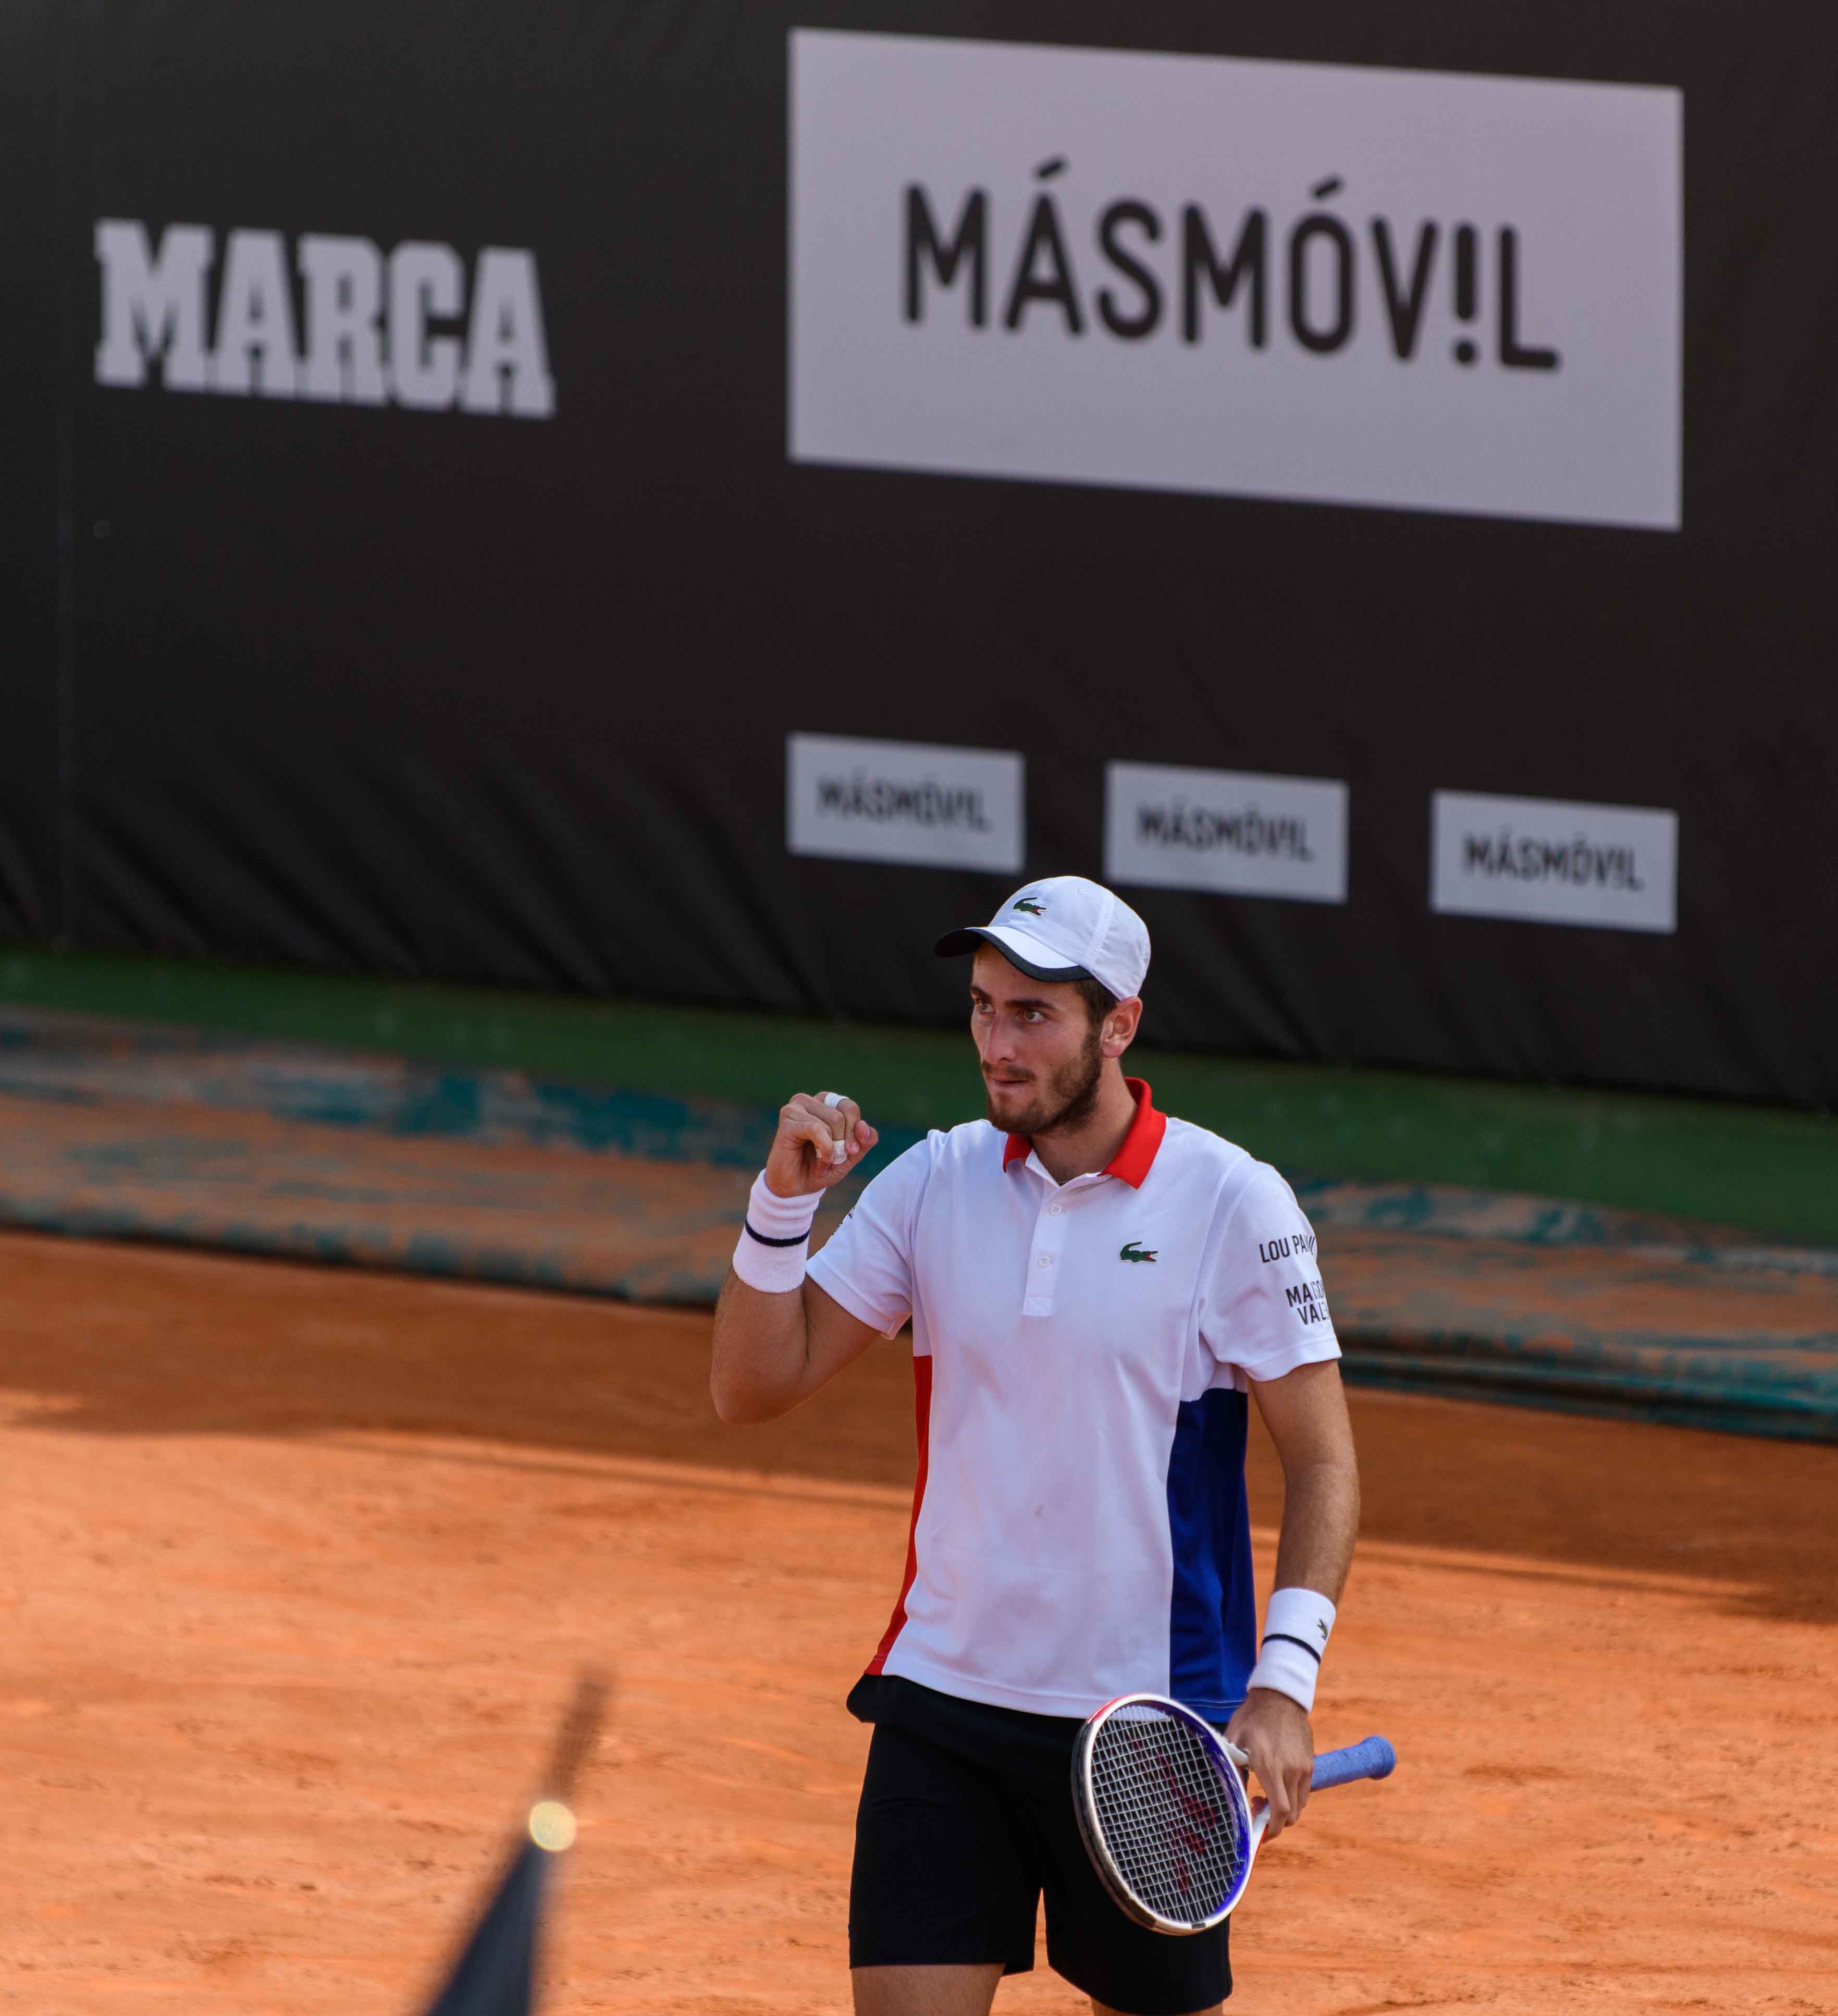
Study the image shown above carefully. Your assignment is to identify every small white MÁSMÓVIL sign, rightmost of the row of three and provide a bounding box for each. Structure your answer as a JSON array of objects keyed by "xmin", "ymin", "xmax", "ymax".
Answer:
[{"xmin": 1429, "ymin": 790, "xmax": 1679, "ymax": 931}]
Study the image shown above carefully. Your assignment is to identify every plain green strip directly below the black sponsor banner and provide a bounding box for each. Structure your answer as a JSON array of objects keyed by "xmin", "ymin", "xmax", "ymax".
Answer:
[{"xmin": 0, "ymin": 950, "xmax": 1838, "ymax": 1246}]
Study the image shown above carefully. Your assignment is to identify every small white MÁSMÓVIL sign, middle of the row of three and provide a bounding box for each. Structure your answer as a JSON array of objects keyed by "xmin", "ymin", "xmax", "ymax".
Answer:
[{"xmin": 1104, "ymin": 762, "xmax": 1346, "ymax": 903}]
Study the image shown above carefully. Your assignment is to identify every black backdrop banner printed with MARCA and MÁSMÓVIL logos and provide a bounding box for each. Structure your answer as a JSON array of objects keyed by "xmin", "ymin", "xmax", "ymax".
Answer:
[{"xmin": 0, "ymin": 0, "xmax": 1838, "ymax": 1103}]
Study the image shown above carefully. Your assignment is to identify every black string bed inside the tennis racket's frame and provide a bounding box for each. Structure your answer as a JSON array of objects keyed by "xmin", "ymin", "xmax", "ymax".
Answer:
[{"xmin": 1090, "ymin": 1710, "xmax": 1245, "ymax": 1925}]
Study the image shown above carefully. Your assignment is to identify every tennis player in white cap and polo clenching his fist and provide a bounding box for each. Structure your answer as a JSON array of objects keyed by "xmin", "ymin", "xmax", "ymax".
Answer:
[{"xmin": 711, "ymin": 875, "xmax": 1359, "ymax": 2016}]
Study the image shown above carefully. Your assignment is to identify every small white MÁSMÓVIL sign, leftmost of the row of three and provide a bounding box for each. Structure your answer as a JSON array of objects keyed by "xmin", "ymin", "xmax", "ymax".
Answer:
[{"xmin": 786, "ymin": 736, "xmax": 1022, "ymax": 875}]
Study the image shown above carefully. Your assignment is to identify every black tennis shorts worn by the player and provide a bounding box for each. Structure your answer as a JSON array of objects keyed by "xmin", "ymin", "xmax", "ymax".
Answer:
[{"xmin": 848, "ymin": 1675, "xmax": 1231, "ymax": 2016}]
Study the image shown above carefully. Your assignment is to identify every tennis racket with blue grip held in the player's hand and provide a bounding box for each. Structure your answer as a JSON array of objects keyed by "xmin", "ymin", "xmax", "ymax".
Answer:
[{"xmin": 1072, "ymin": 1693, "xmax": 1397, "ymax": 1933}]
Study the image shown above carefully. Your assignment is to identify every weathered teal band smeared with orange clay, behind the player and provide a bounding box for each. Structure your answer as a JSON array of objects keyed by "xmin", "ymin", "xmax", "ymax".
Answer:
[{"xmin": 0, "ymin": 1004, "xmax": 1838, "ymax": 1440}]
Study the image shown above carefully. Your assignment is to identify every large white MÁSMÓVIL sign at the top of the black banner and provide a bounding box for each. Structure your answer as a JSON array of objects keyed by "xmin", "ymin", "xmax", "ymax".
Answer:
[{"xmin": 790, "ymin": 28, "xmax": 1683, "ymax": 530}]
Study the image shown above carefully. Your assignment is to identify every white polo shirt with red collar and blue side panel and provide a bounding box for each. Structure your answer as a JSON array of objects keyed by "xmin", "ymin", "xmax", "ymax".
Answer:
[{"xmin": 810, "ymin": 1078, "xmax": 1340, "ymax": 1719}]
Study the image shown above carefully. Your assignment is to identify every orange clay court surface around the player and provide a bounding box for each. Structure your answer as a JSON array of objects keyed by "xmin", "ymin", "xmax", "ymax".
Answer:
[{"xmin": 0, "ymin": 1236, "xmax": 1838, "ymax": 2016}]
